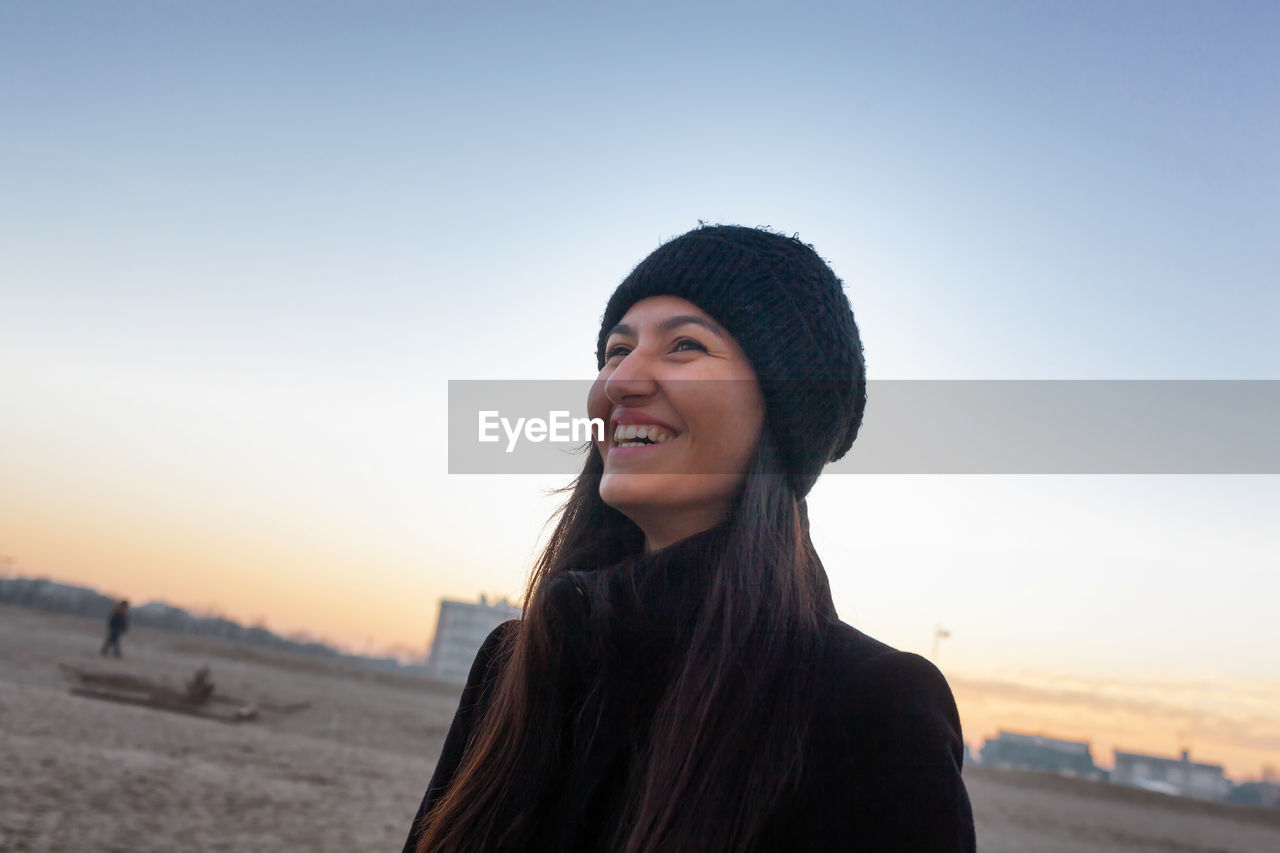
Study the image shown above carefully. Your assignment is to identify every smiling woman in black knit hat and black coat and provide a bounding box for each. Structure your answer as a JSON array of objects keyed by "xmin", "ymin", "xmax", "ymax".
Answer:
[{"xmin": 404, "ymin": 225, "xmax": 974, "ymax": 853}]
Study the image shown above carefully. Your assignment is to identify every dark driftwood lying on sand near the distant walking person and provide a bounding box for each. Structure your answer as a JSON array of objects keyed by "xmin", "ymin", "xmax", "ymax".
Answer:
[{"xmin": 59, "ymin": 663, "xmax": 310, "ymax": 722}]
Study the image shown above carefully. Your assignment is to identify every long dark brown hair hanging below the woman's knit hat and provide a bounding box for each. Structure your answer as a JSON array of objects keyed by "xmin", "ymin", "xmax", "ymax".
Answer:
[{"xmin": 417, "ymin": 428, "xmax": 835, "ymax": 853}]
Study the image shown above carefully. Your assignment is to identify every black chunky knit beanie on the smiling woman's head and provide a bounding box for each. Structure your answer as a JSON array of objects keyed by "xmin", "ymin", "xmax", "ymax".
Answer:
[{"xmin": 595, "ymin": 225, "xmax": 867, "ymax": 497}]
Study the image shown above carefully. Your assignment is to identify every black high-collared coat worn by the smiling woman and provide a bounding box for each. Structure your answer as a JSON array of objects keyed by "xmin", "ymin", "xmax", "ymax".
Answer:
[{"xmin": 404, "ymin": 532, "xmax": 975, "ymax": 853}]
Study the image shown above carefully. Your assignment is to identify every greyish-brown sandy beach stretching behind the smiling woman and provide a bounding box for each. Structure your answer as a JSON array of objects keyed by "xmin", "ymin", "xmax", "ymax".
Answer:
[{"xmin": 0, "ymin": 606, "xmax": 1280, "ymax": 853}]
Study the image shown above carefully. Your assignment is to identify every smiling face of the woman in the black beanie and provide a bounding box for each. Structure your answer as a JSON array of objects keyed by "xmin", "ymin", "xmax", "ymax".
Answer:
[{"xmin": 588, "ymin": 296, "xmax": 764, "ymax": 549}]
